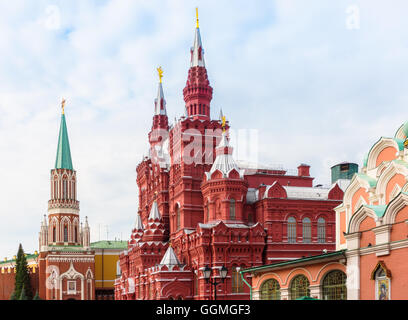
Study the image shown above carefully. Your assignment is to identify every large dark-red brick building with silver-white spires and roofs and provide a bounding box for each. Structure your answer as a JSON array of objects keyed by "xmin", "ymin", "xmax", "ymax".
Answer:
[{"xmin": 115, "ymin": 13, "xmax": 343, "ymax": 300}]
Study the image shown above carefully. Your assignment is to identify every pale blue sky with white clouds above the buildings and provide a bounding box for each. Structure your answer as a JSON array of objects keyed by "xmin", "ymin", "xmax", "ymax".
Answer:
[{"xmin": 0, "ymin": 0, "xmax": 408, "ymax": 259}]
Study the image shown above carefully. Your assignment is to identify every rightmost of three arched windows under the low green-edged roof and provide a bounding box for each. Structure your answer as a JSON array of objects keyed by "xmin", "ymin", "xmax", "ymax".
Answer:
[{"xmin": 322, "ymin": 270, "xmax": 347, "ymax": 300}]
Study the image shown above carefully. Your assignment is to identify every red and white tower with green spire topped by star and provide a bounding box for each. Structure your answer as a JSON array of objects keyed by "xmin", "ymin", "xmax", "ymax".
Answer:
[{"xmin": 39, "ymin": 100, "xmax": 95, "ymax": 300}]
